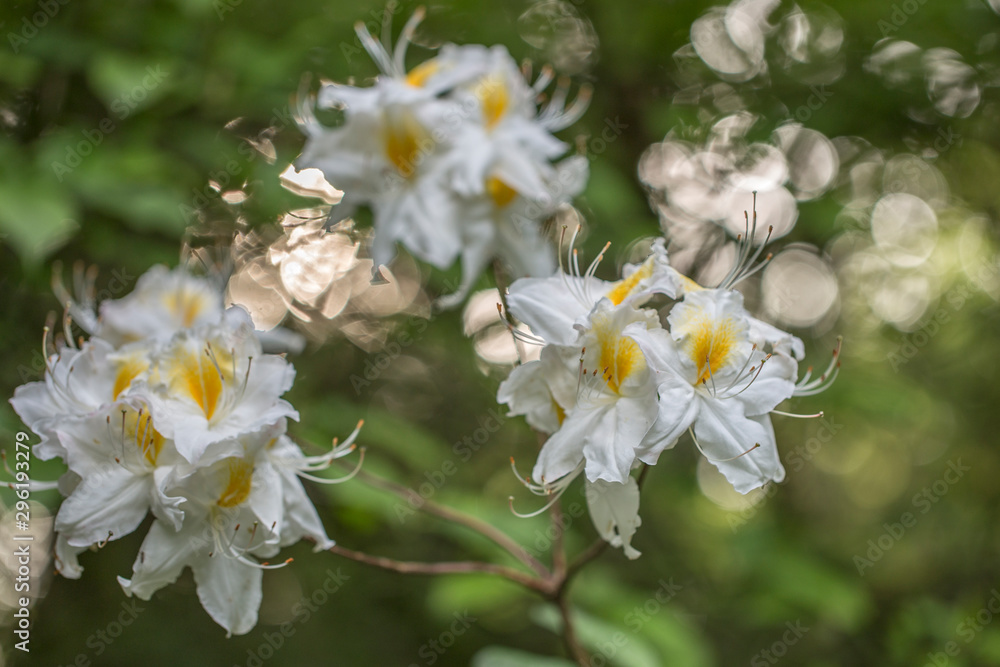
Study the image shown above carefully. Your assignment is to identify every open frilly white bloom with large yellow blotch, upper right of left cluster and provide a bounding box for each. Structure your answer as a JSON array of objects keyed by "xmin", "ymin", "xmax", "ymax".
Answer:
[{"xmin": 134, "ymin": 308, "xmax": 298, "ymax": 463}]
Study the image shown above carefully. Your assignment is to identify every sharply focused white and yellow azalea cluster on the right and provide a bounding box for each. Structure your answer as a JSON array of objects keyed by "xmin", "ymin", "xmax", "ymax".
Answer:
[{"xmin": 498, "ymin": 216, "xmax": 837, "ymax": 558}]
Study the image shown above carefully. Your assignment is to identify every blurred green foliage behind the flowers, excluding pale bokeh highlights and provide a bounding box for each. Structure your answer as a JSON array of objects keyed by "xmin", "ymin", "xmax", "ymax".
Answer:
[{"xmin": 0, "ymin": 0, "xmax": 1000, "ymax": 667}]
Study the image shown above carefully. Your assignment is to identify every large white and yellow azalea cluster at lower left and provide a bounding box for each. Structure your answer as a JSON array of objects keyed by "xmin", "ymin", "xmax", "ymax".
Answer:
[{"xmin": 11, "ymin": 266, "xmax": 357, "ymax": 634}]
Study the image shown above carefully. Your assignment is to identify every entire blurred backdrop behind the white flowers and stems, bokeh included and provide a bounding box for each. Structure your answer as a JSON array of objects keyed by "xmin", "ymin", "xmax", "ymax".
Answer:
[{"xmin": 0, "ymin": 0, "xmax": 1000, "ymax": 667}]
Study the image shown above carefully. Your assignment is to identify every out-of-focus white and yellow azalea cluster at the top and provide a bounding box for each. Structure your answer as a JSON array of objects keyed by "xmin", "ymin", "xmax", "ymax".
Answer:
[{"xmin": 296, "ymin": 10, "xmax": 589, "ymax": 307}]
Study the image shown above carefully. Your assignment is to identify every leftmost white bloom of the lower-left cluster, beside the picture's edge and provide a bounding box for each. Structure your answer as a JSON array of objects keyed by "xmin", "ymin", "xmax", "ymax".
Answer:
[{"xmin": 10, "ymin": 336, "xmax": 152, "ymax": 459}]
